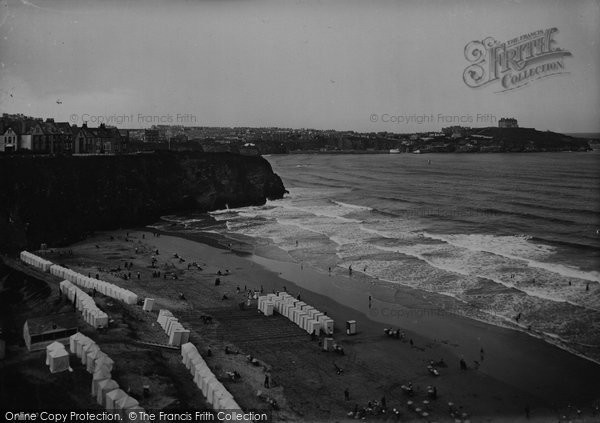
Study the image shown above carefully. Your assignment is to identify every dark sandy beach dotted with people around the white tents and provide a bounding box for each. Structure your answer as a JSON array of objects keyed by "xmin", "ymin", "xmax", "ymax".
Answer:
[{"xmin": 9, "ymin": 230, "xmax": 600, "ymax": 421}]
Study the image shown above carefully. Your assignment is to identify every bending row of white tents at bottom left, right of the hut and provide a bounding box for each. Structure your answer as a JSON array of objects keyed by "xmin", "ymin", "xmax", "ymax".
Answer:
[{"xmin": 69, "ymin": 332, "xmax": 144, "ymax": 421}]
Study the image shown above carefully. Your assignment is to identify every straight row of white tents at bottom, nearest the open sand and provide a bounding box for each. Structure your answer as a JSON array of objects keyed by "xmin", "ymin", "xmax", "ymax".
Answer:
[{"xmin": 181, "ymin": 342, "xmax": 241, "ymax": 411}]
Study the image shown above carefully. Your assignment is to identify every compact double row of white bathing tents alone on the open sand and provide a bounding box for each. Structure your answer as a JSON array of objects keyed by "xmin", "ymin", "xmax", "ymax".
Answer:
[{"xmin": 258, "ymin": 292, "xmax": 334, "ymax": 335}]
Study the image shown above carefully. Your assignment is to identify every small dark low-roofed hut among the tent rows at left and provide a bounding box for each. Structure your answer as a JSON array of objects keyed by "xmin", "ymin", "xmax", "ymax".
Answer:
[{"xmin": 23, "ymin": 312, "xmax": 78, "ymax": 351}]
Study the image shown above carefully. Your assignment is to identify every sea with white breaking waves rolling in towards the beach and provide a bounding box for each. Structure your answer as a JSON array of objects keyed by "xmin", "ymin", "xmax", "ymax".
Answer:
[{"xmin": 157, "ymin": 151, "xmax": 600, "ymax": 362}]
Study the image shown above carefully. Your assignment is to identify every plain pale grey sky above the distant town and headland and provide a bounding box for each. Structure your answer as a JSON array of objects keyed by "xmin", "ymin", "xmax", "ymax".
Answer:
[{"xmin": 0, "ymin": 0, "xmax": 600, "ymax": 133}]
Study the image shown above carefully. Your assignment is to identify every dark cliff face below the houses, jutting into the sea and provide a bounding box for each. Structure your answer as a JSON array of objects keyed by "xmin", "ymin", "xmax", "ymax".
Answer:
[{"xmin": 0, "ymin": 153, "xmax": 285, "ymax": 252}]
